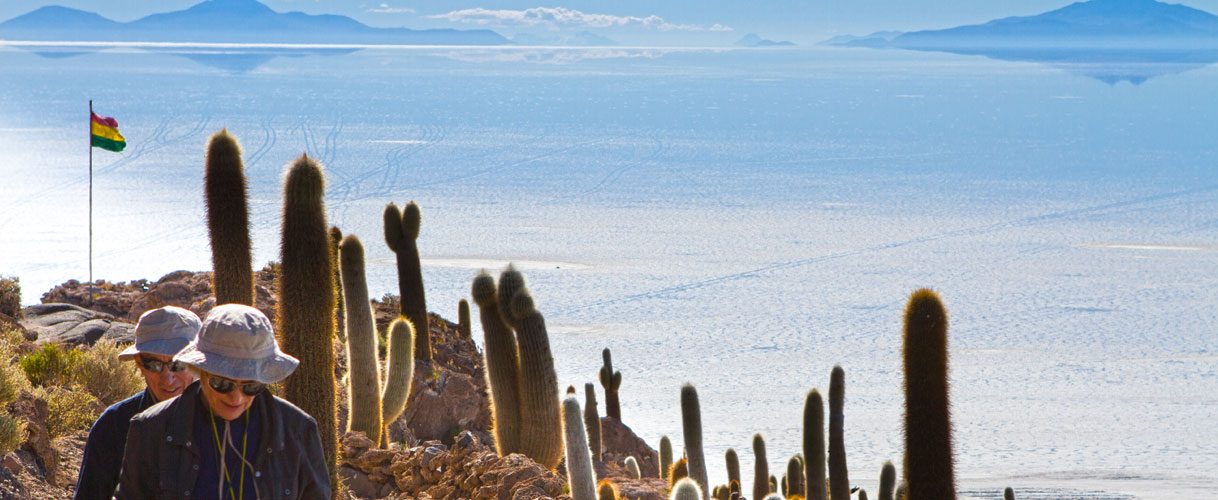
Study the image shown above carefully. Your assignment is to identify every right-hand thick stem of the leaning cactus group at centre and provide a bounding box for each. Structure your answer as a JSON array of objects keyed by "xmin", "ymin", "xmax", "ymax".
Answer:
[{"xmin": 499, "ymin": 283, "xmax": 563, "ymax": 468}]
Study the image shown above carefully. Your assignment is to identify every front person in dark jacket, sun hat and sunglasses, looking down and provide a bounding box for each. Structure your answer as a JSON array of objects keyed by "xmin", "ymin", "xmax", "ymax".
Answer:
[{"xmin": 114, "ymin": 304, "xmax": 330, "ymax": 500}]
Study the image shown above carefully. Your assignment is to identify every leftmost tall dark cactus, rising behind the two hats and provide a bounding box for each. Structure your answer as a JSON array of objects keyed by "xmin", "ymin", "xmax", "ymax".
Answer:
[{"xmin": 203, "ymin": 129, "xmax": 253, "ymax": 305}]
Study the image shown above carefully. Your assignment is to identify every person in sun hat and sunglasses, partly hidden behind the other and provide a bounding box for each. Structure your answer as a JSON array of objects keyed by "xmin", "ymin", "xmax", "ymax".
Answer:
[{"xmin": 74, "ymin": 305, "xmax": 200, "ymax": 500}]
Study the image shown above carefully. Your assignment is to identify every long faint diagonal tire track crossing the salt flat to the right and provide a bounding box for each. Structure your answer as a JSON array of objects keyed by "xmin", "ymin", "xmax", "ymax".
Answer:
[{"xmin": 555, "ymin": 185, "xmax": 1218, "ymax": 314}]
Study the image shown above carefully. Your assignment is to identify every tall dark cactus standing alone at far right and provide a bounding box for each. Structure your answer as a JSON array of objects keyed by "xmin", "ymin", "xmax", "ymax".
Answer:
[{"xmin": 903, "ymin": 288, "xmax": 956, "ymax": 500}]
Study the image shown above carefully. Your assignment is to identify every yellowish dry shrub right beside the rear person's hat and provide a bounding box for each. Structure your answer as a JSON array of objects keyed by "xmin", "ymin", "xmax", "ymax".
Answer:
[{"xmin": 72, "ymin": 339, "xmax": 144, "ymax": 406}]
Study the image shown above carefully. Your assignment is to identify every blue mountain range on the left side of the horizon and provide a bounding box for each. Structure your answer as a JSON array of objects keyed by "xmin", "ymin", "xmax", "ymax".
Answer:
[{"xmin": 0, "ymin": 0, "xmax": 509, "ymax": 45}]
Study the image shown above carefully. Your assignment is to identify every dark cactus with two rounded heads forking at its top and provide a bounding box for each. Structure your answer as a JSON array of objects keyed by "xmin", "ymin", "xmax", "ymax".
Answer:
[{"xmin": 384, "ymin": 202, "xmax": 431, "ymax": 361}]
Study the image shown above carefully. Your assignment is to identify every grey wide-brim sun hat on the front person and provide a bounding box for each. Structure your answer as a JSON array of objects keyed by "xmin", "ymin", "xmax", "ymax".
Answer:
[{"xmin": 173, "ymin": 304, "xmax": 300, "ymax": 383}]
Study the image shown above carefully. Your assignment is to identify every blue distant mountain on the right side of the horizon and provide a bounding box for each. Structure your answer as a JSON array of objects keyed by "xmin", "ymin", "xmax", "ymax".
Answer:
[{"xmin": 821, "ymin": 0, "xmax": 1218, "ymax": 51}]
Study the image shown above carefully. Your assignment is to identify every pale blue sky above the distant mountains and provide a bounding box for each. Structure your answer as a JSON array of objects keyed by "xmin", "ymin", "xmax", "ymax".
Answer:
[{"xmin": 7, "ymin": 0, "xmax": 1218, "ymax": 45}]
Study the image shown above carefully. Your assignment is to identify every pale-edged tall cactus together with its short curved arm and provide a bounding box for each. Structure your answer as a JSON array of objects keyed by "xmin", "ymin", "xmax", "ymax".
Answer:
[{"xmin": 339, "ymin": 236, "xmax": 414, "ymax": 445}]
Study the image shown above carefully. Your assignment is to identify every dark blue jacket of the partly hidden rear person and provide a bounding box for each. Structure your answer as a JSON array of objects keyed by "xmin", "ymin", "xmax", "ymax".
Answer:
[{"xmin": 76, "ymin": 389, "xmax": 156, "ymax": 500}]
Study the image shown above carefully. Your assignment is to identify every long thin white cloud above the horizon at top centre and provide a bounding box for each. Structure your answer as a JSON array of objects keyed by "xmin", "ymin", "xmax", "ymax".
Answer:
[{"xmin": 428, "ymin": 7, "xmax": 732, "ymax": 32}]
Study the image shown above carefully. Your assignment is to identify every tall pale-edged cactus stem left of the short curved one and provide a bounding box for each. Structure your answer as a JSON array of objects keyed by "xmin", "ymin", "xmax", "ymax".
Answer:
[{"xmin": 339, "ymin": 236, "xmax": 384, "ymax": 443}]
